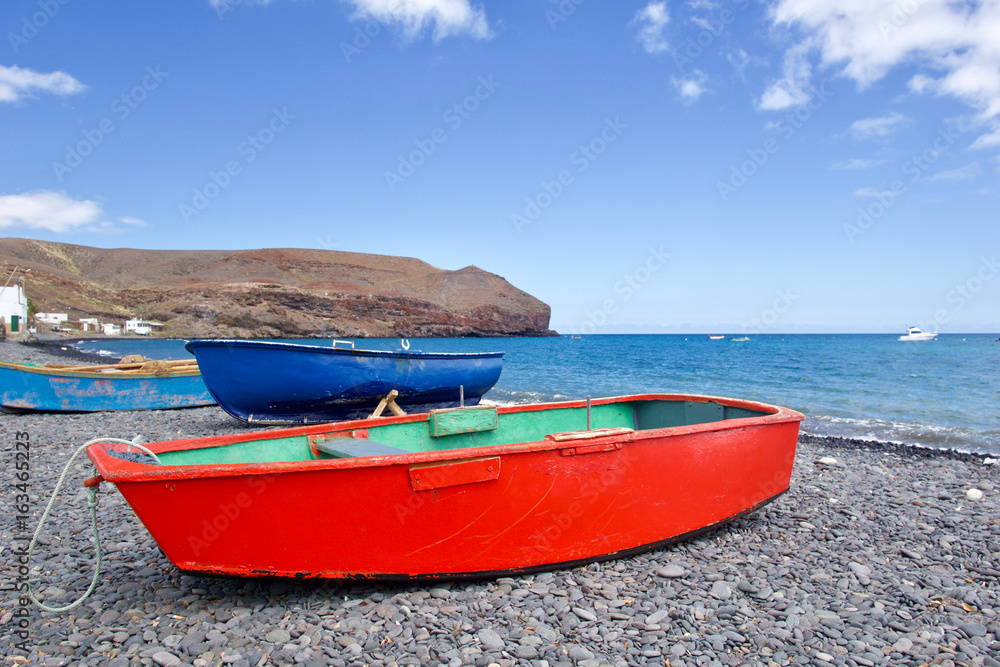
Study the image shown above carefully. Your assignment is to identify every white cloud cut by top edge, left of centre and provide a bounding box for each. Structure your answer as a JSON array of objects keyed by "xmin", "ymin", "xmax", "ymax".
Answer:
[{"xmin": 347, "ymin": 0, "xmax": 493, "ymax": 41}]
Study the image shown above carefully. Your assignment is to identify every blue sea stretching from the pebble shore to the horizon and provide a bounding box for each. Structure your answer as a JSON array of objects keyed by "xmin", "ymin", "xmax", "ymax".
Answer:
[{"xmin": 73, "ymin": 334, "xmax": 1000, "ymax": 456}]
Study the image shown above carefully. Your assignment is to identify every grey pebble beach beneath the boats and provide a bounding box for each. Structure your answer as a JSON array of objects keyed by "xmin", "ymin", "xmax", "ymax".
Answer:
[{"xmin": 0, "ymin": 341, "xmax": 1000, "ymax": 667}]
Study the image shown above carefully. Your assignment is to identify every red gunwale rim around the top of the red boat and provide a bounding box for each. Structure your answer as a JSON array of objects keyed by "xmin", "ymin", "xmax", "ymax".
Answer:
[{"xmin": 87, "ymin": 394, "xmax": 805, "ymax": 484}]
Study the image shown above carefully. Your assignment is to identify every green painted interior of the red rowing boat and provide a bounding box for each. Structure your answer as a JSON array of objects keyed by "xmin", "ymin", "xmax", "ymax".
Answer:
[{"xmin": 152, "ymin": 400, "xmax": 771, "ymax": 465}]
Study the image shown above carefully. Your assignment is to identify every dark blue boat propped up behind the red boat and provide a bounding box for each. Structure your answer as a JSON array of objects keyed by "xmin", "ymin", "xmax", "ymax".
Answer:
[{"xmin": 185, "ymin": 340, "xmax": 503, "ymax": 424}]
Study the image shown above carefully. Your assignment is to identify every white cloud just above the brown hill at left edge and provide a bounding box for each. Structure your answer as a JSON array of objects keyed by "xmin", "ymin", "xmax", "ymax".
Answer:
[{"xmin": 0, "ymin": 190, "xmax": 104, "ymax": 232}]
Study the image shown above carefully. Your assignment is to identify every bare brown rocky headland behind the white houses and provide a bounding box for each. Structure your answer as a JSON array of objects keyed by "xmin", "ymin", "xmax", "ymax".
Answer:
[{"xmin": 0, "ymin": 238, "xmax": 553, "ymax": 337}]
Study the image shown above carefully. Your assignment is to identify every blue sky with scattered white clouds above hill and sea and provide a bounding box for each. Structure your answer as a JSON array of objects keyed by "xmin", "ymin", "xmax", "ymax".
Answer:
[{"xmin": 0, "ymin": 0, "xmax": 1000, "ymax": 333}]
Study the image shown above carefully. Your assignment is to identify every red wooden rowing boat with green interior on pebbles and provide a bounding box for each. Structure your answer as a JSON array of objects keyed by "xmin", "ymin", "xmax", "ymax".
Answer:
[{"xmin": 87, "ymin": 394, "xmax": 803, "ymax": 580}]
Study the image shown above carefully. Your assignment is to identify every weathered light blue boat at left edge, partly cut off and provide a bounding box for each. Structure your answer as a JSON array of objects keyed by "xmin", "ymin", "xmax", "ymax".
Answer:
[{"xmin": 0, "ymin": 359, "xmax": 215, "ymax": 412}]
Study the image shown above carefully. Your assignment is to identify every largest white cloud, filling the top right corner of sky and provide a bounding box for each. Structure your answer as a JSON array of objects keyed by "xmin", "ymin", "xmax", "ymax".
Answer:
[{"xmin": 765, "ymin": 0, "xmax": 1000, "ymax": 144}]
